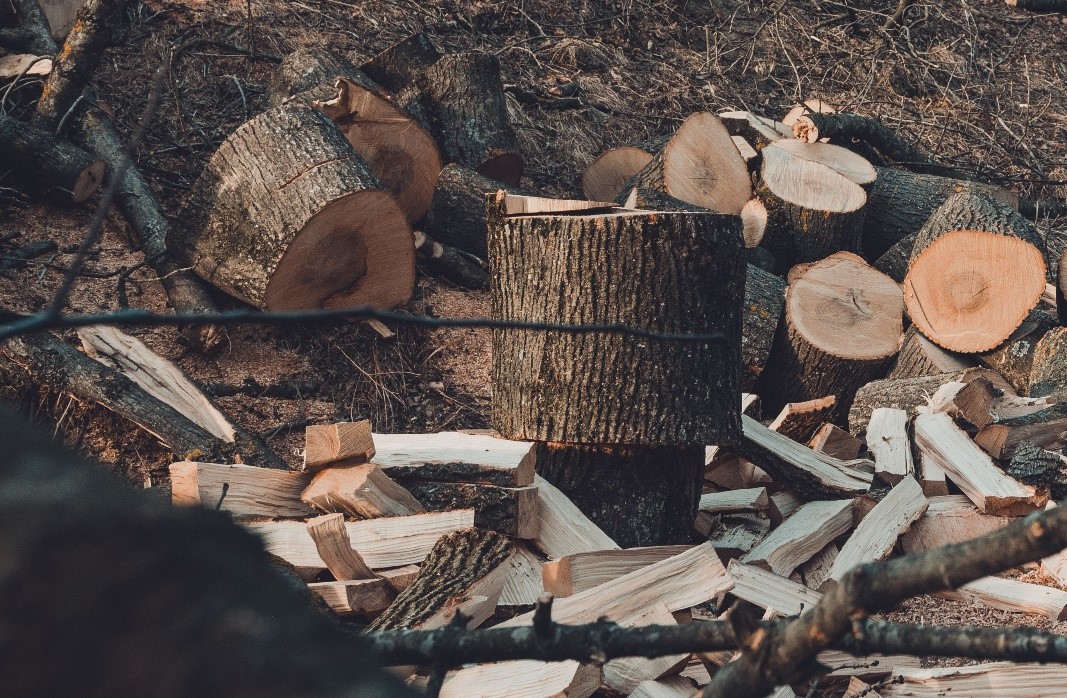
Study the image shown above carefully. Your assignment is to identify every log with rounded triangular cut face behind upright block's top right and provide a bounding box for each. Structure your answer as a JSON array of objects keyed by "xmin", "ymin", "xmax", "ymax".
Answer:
[{"xmin": 620, "ymin": 112, "xmax": 752, "ymax": 216}]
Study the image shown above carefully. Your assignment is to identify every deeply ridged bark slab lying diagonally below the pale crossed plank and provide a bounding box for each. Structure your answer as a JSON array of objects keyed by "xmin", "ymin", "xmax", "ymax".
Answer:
[{"xmin": 368, "ymin": 528, "xmax": 512, "ymax": 631}]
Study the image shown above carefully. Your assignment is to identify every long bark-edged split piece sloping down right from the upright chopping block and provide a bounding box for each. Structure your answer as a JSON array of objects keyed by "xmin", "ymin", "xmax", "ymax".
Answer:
[{"xmin": 731, "ymin": 415, "xmax": 874, "ymax": 497}]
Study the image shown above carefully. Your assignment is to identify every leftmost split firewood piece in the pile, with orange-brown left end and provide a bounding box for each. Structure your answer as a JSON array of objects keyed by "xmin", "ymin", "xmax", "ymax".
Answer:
[{"xmin": 171, "ymin": 461, "xmax": 315, "ymax": 519}]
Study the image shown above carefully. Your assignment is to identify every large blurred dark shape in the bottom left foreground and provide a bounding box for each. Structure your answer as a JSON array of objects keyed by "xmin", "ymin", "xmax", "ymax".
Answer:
[{"xmin": 0, "ymin": 411, "xmax": 411, "ymax": 698}]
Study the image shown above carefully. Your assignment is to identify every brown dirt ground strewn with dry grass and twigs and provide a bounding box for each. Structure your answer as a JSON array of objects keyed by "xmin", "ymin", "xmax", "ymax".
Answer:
[{"xmin": 0, "ymin": 0, "xmax": 1067, "ymax": 683}]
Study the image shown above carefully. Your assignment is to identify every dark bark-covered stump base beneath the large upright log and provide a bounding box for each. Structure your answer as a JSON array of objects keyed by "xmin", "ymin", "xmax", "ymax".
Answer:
[{"xmin": 537, "ymin": 443, "xmax": 704, "ymax": 548}]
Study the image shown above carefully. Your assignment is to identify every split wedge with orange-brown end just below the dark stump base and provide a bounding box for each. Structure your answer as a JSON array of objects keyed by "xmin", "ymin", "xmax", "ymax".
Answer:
[{"xmin": 541, "ymin": 545, "xmax": 691, "ymax": 597}]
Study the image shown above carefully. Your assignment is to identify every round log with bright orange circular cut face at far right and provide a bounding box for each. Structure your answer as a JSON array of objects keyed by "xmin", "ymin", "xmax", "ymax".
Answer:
[{"xmin": 904, "ymin": 192, "xmax": 1046, "ymax": 353}]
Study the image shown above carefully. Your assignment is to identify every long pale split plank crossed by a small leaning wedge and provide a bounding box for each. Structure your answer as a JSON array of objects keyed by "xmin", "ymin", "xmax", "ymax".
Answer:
[{"xmin": 242, "ymin": 509, "xmax": 474, "ymax": 570}]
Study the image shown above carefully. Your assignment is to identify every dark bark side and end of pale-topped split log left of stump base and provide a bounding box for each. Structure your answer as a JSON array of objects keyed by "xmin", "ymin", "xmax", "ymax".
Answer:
[{"xmin": 408, "ymin": 482, "xmax": 538, "ymax": 540}]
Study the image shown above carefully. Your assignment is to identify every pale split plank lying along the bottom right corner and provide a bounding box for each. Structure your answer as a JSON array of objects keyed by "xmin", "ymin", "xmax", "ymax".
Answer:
[{"xmin": 878, "ymin": 662, "xmax": 1067, "ymax": 698}]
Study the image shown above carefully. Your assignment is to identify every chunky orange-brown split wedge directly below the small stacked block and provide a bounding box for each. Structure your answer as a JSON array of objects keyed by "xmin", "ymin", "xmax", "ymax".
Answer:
[{"xmin": 300, "ymin": 463, "xmax": 426, "ymax": 519}]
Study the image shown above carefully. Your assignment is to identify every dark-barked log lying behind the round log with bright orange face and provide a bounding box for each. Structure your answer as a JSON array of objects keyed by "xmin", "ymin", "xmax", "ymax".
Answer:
[{"xmin": 863, "ymin": 168, "xmax": 1019, "ymax": 259}]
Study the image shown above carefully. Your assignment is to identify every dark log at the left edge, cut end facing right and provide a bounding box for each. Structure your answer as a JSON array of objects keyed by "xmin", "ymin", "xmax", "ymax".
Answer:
[{"xmin": 0, "ymin": 114, "xmax": 108, "ymax": 204}]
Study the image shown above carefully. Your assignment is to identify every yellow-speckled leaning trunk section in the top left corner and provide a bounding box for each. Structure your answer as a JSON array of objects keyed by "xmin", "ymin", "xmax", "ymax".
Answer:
[{"xmin": 32, "ymin": 0, "xmax": 128, "ymax": 131}]
